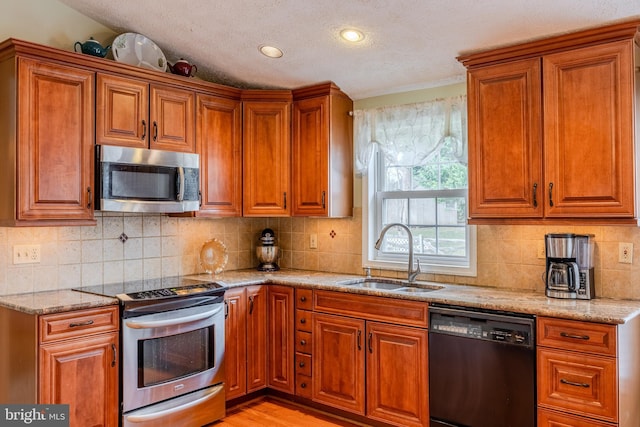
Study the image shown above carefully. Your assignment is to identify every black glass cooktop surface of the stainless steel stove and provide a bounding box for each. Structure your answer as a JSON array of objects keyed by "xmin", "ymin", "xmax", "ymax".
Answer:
[{"xmin": 73, "ymin": 276, "xmax": 226, "ymax": 301}]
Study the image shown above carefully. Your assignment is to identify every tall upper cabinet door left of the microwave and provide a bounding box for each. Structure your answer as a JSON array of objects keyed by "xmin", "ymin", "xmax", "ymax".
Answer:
[{"xmin": 17, "ymin": 58, "xmax": 95, "ymax": 225}]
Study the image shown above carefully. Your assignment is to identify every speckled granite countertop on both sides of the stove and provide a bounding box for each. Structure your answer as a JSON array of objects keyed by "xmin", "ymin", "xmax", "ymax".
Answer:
[{"xmin": 0, "ymin": 270, "xmax": 640, "ymax": 324}]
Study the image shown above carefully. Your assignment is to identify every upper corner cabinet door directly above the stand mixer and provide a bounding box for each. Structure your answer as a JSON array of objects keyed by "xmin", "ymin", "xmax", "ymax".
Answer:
[{"xmin": 243, "ymin": 101, "xmax": 291, "ymax": 216}]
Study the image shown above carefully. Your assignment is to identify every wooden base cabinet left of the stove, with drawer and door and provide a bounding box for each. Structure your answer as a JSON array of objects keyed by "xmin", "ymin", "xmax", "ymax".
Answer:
[{"xmin": 0, "ymin": 306, "xmax": 120, "ymax": 427}]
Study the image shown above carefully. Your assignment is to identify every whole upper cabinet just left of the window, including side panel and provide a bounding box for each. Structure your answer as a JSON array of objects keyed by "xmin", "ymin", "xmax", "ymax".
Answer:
[{"xmin": 291, "ymin": 83, "xmax": 353, "ymax": 217}]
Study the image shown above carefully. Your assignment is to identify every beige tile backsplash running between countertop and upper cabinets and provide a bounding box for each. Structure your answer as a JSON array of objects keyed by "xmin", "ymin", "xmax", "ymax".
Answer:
[{"xmin": 0, "ymin": 208, "xmax": 640, "ymax": 299}]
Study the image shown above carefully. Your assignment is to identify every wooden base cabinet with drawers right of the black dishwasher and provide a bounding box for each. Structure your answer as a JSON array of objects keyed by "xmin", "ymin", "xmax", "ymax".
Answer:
[{"xmin": 537, "ymin": 317, "xmax": 640, "ymax": 427}]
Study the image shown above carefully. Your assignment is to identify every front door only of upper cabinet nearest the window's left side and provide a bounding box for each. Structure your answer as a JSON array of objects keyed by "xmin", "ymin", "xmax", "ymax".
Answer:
[{"xmin": 291, "ymin": 96, "xmax": 329, "ymax": 216}]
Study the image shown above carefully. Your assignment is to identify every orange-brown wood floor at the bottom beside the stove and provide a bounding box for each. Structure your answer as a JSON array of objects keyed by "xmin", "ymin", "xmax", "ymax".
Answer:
[{"xmin": 208, "ymin": 397, "xmax": 362, "ymax": 427}]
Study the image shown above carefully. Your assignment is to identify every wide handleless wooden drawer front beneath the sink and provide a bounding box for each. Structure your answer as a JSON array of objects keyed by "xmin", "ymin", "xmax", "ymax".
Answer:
[{"xmin": 313, "ymin": 290, "xmax": 429, "ymax": 328}]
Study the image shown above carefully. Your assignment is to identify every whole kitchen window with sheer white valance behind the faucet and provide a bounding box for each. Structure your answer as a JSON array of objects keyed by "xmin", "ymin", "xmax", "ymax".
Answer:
[{"xmin": 356, "ymin": 97, "xmax": 475, "ymax": 275}]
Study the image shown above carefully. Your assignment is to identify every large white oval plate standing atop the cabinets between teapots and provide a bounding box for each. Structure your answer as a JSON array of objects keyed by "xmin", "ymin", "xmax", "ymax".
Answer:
[{"xmin": 111, "ymin": 33, "xmax": 167, "ymax": 71}]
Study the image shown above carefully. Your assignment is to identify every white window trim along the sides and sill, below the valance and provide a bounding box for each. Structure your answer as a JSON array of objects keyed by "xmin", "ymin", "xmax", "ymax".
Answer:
[{"xmin": 362, "ymin": 147, "xmax": 477, "ymax": 277}]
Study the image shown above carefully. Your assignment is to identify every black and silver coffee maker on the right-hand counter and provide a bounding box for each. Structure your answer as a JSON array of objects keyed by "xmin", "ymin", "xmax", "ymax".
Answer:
[{"xmin": 544, "ymin": 233, "xmax": 595, "ymax": 299}]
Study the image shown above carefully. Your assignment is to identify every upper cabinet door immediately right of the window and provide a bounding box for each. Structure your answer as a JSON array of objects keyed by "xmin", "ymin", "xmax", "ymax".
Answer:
[{"xmin": 467, "ymin": 58, "xmax": 543, "ymax": 219}]
